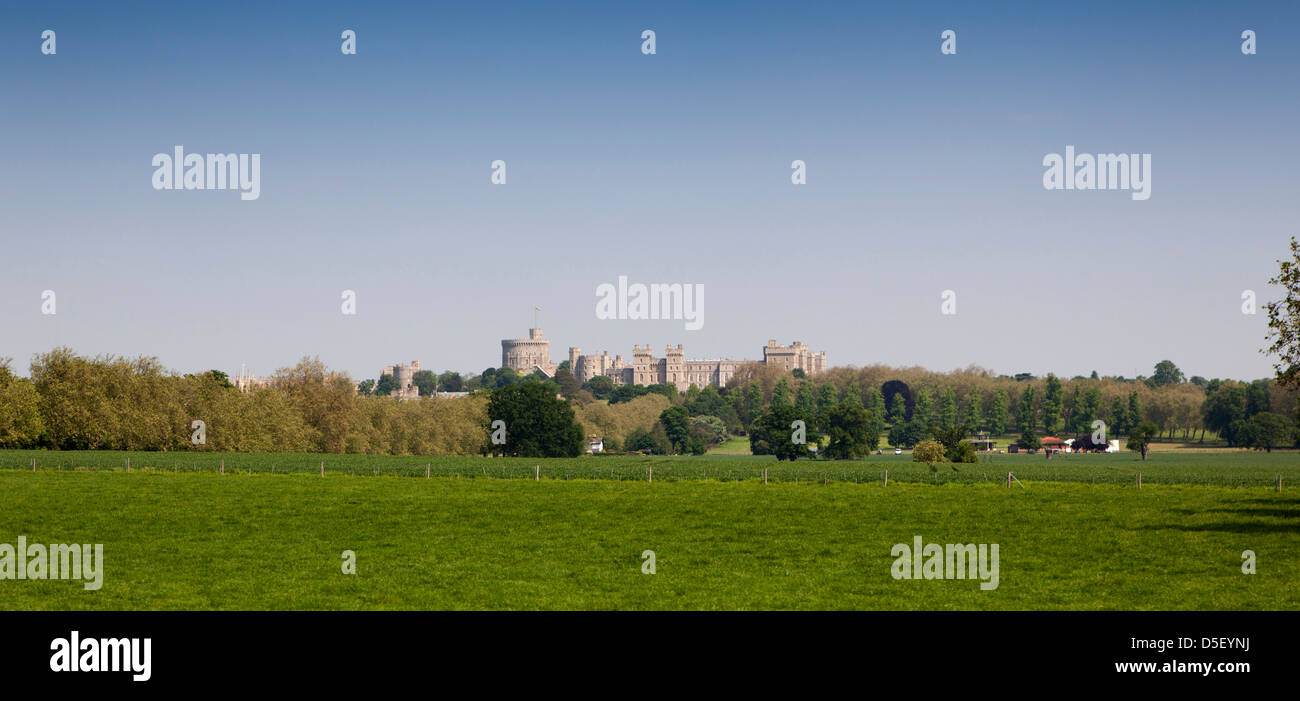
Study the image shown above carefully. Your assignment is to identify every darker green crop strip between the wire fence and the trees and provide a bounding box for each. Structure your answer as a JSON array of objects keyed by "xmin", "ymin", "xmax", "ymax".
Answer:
[{"xmin": 0, "ymin": 450, "xmax": 1300, "ymax": 488}]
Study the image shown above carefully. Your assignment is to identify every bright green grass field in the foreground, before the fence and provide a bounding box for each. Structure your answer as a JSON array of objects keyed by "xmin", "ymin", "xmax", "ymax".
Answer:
[{"xmin": 0, "ymin": 463, "xmax": 1300, "ymax": 610}]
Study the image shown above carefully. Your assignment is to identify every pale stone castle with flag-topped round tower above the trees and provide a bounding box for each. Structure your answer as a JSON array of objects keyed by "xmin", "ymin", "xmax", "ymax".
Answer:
[{"xmin": 501, "ymin": 329, "xmax": 826, "ymax": 391}]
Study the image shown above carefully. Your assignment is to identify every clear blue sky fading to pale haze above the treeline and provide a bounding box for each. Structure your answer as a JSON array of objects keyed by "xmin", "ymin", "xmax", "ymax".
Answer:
[{"xmin": 0, "ymin": 1, "xmax": 1300, "ymax": 378}]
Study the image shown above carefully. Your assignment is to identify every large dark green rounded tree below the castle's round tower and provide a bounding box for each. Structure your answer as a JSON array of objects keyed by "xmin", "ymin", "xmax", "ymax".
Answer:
[{"xmin": 488, "ymin": 382, "xmax": 584, "ymax": 458}]
